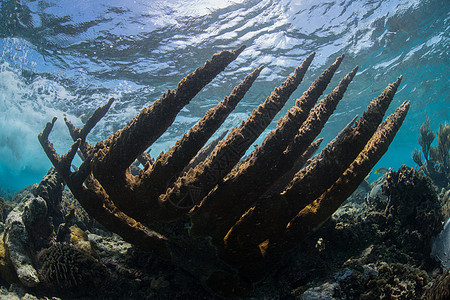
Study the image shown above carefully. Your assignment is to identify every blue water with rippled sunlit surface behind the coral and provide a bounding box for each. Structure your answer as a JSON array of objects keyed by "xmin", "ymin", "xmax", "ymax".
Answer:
[{"xmin": 0, "ymin": 0, "xmax": 450, "ymax": 193}]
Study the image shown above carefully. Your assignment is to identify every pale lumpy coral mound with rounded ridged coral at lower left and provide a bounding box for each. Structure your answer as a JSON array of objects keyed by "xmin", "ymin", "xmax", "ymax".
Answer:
[{"xmin": 0, "ymin": 168, "xmax": 110, "ymax": 294}]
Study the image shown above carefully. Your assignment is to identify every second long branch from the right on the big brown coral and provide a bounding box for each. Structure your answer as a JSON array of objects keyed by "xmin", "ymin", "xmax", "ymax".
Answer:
[{"xmin": 226, "ymin": 77, "xmax": 401, "ymax": 258}]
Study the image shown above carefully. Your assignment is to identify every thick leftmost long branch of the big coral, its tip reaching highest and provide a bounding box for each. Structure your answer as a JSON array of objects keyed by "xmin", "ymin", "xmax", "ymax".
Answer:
[{"xmin": 92, "ymin": 46, "xmax": 244, "ymax": 198}]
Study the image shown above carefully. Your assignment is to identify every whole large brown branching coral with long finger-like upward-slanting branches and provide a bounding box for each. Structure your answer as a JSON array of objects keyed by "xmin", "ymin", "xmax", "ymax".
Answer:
[{"xmin": 39, "ymin": 47, "xmax": 409, "ymax": 296}]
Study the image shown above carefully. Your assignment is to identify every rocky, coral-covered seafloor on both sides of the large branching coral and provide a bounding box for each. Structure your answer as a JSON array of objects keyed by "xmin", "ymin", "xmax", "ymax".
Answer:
[{"xmin": 0, "ymin": 166, "xmax": 450, "ymax": 299}]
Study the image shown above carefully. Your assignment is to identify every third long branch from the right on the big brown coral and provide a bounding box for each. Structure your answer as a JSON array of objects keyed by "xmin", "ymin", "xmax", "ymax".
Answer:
[{"xmin": 193, "ymin": 63, "xmax": 357, "ymax": 240}]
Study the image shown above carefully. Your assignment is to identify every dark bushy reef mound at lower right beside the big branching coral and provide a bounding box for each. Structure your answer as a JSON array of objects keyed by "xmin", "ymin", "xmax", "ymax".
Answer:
[{"xmin": 282, "ymin": 166, "xmax": 442, "ymax": 299}]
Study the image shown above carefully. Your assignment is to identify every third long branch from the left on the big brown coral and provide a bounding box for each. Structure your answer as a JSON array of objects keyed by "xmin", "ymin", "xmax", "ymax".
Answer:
[{"xmin": 160, "ymin": 51, "xmax": 313, "ymax": 222}]
